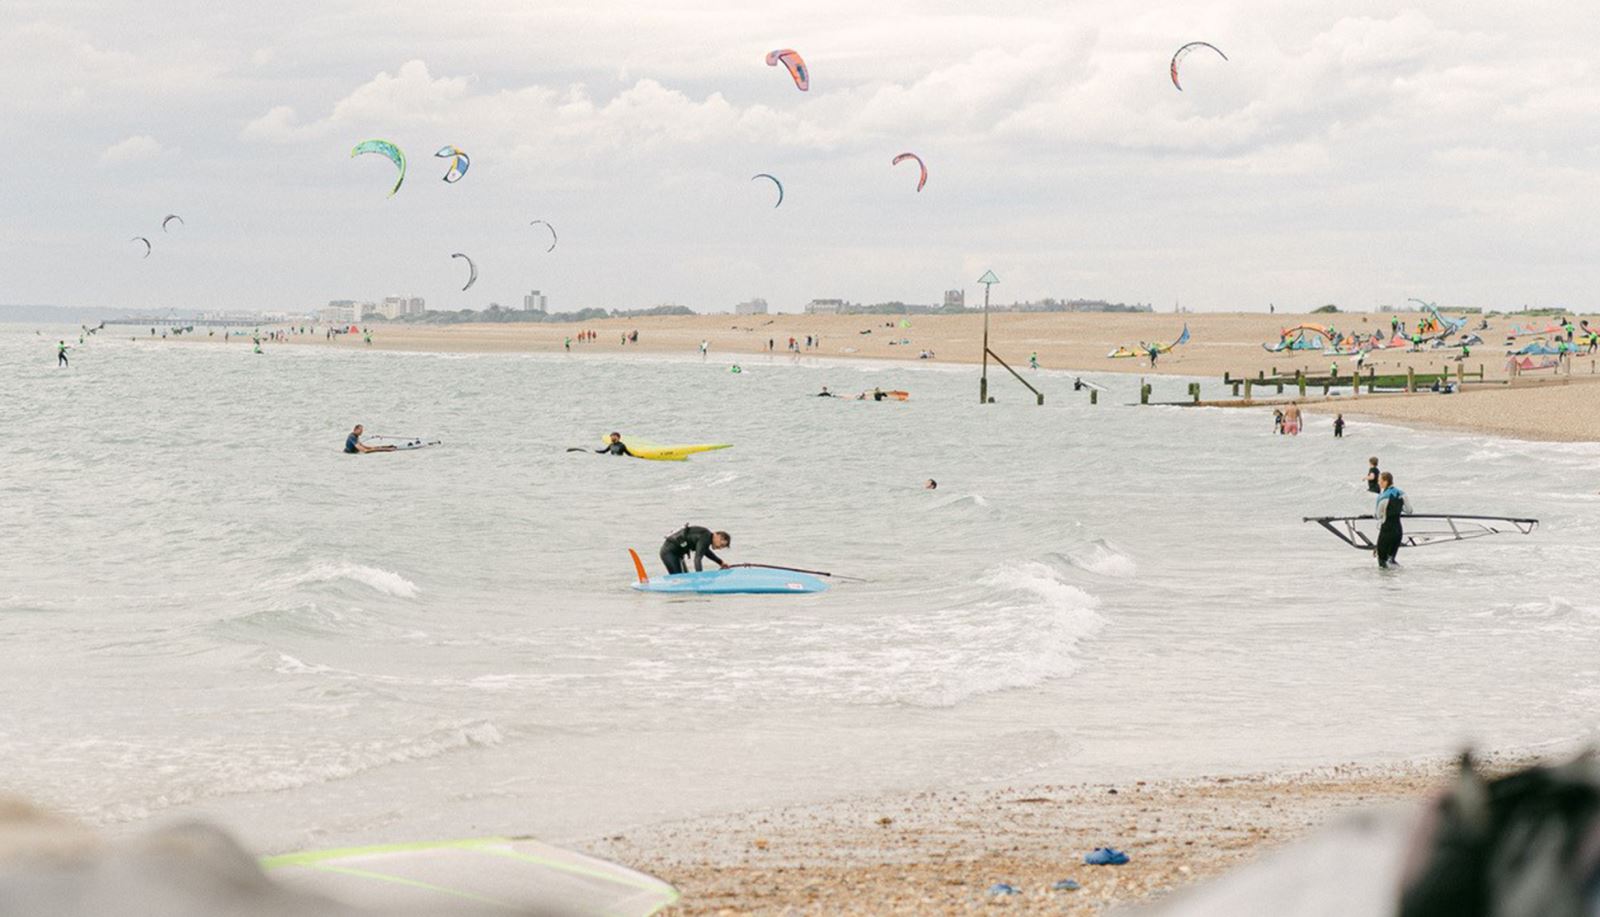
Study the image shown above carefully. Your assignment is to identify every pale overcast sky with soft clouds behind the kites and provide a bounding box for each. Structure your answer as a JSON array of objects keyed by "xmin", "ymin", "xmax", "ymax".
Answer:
[{"xmin": 0, "ymin": 0, "xmax": 1600, "ymax": 312}]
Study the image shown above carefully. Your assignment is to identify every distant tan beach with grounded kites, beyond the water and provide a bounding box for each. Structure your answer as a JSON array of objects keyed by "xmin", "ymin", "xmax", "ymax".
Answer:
[{"xmin": 222, "ymin": 312, "xmax": 1600, "ymax": 442}]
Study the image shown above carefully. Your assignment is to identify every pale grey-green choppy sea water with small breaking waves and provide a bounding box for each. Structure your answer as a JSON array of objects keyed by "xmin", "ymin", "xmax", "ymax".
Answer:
[{"xmin": 0, "ymin": 326, "xmax": 1600, "ymax": 850}]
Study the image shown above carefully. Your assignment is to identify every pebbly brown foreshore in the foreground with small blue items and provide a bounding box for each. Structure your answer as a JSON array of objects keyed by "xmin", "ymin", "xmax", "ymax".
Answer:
[{"xmin": 589, "ymin": 760, "xmax": 1536, "ymax": 915}]
